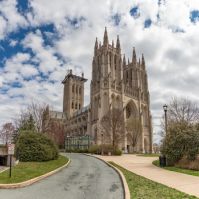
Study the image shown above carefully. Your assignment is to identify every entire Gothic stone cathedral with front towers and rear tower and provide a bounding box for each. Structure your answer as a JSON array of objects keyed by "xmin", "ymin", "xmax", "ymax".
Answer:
[{"xmin": 46, "ymin": 28, "xmax": 152, "ymax": 153}]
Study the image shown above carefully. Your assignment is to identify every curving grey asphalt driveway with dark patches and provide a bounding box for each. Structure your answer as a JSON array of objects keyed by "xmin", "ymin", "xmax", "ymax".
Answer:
[{"xmin": 0, "ymin": 154, "xmax": 124, "ymax": 199}]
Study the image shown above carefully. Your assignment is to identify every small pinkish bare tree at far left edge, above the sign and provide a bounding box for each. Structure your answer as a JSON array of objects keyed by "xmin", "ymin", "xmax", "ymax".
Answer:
[{"xmin": 0, "ymin": 123, "xmax": 15, "ymax": 144}]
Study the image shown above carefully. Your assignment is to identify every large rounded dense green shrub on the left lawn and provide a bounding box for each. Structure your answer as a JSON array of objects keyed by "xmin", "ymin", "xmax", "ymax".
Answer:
[{"xmin": 16, "ymin": 131, "xmax": 58, "ymax": 162}]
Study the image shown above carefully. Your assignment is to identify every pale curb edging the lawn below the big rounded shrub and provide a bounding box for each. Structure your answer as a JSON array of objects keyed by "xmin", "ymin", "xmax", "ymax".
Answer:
[{"xmin": 0, "ymin": 159, "xmax": 71, "ymax": 189}]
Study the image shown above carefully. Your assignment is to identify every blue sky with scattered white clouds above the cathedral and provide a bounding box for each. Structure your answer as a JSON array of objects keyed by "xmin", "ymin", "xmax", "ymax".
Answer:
[{"xmin": 0, "ymin": 0, "xmax": 199, "ymax": 142}]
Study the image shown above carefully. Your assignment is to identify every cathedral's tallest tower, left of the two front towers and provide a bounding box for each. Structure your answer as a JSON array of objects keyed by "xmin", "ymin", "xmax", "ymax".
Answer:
[{"xmin": 91, "ymin": 28, "xmax": 122, "ymax": 141}]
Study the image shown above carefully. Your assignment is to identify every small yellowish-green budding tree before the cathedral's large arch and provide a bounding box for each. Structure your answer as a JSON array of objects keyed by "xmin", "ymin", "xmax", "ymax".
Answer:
[{"xmin": 126, "ymin": 117, "xmax": 142, "ymax": 152}]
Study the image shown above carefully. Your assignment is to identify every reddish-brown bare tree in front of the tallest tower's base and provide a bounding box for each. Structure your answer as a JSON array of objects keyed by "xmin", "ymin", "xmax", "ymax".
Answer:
[{"xmin": 100, "ymin": 108, "xmax": 125, "ymax": 148}]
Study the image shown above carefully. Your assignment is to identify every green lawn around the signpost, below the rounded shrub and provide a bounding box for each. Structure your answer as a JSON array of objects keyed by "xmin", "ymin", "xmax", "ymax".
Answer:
[{"xmin": 0, "ymin": 155, "xmax": 68, "ymax": 184}]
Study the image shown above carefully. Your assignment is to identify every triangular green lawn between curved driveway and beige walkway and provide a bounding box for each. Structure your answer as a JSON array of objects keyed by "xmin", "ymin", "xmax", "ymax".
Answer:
[{"xmin": 110, "ymin": 162, "xmax": 197, "ymax": 199}]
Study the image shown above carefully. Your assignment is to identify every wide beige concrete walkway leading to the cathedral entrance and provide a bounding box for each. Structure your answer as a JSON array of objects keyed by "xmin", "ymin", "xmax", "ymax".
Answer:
[{"xmin": 94, "ymin": 154, "xmax": 199, "ymax": 197}]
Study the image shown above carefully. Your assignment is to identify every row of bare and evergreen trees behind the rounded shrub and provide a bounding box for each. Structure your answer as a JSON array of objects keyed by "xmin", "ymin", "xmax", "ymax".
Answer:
[{"xmin": 0, "ymin": 102, "xmax": 64, "ymax": 148}]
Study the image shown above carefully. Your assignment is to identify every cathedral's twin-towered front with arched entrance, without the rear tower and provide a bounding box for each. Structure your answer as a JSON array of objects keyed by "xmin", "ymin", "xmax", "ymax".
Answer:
[{"xmin": 89, "ymin": 28, "xmax": 152, "ymax": 152}]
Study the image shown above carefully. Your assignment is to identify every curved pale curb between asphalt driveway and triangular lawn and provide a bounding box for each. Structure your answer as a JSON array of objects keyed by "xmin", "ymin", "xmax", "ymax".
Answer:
[{"xmin": 84, "ymin": 153, "xmax": 131, "ymax": 199}]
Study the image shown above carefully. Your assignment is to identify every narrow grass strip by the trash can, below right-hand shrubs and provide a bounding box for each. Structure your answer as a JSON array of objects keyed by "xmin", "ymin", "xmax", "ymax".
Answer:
[{"xmin": 153, "ymin": 160, "xmax": 199, "ymax": 176}]
